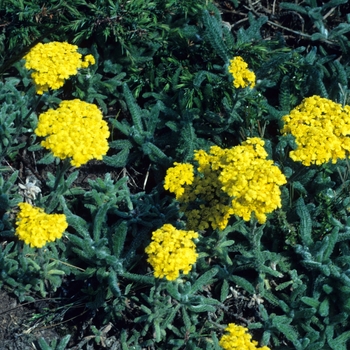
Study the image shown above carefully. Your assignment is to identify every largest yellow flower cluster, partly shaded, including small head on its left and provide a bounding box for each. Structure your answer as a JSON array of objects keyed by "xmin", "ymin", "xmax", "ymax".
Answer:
[{"xmin": 164, "ymin": 137, "xmax": 286, "ymax": 230}]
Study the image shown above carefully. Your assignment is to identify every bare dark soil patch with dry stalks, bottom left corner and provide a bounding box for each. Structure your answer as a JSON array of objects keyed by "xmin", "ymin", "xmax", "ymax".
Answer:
[{"xmin": 0, "ymin": 290, "xmax": 121, "ymax": 350}]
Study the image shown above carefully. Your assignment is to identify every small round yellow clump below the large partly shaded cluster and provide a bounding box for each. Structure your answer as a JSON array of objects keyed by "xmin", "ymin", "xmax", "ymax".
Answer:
[{"xmin": 145, "ymin": 224, "xmax": 198, "ymax": 281}]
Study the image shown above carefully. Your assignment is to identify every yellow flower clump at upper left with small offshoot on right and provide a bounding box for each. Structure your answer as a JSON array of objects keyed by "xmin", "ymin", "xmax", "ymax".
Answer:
[{"xmin": 24, "ymin": 41, "xmax": 95, "ymax": 95}]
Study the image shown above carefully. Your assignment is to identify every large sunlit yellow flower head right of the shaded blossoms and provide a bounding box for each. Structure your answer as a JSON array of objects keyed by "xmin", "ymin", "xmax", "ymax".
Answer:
[{"xmin": 219, "ymin": 137, "xmax": 287, "ymax": 224}]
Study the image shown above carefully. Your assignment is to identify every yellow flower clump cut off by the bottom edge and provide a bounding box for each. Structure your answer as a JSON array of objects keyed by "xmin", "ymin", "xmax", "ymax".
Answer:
[{"xmin": 219, "ymin": 323, "xmax": 270, "ymax": 350}]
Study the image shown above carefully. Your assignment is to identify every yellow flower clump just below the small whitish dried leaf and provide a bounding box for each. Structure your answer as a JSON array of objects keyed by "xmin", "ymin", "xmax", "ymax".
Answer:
[{"xmin": 15, "ymin": 203, "xmax": 68, "ymax": 248}]
